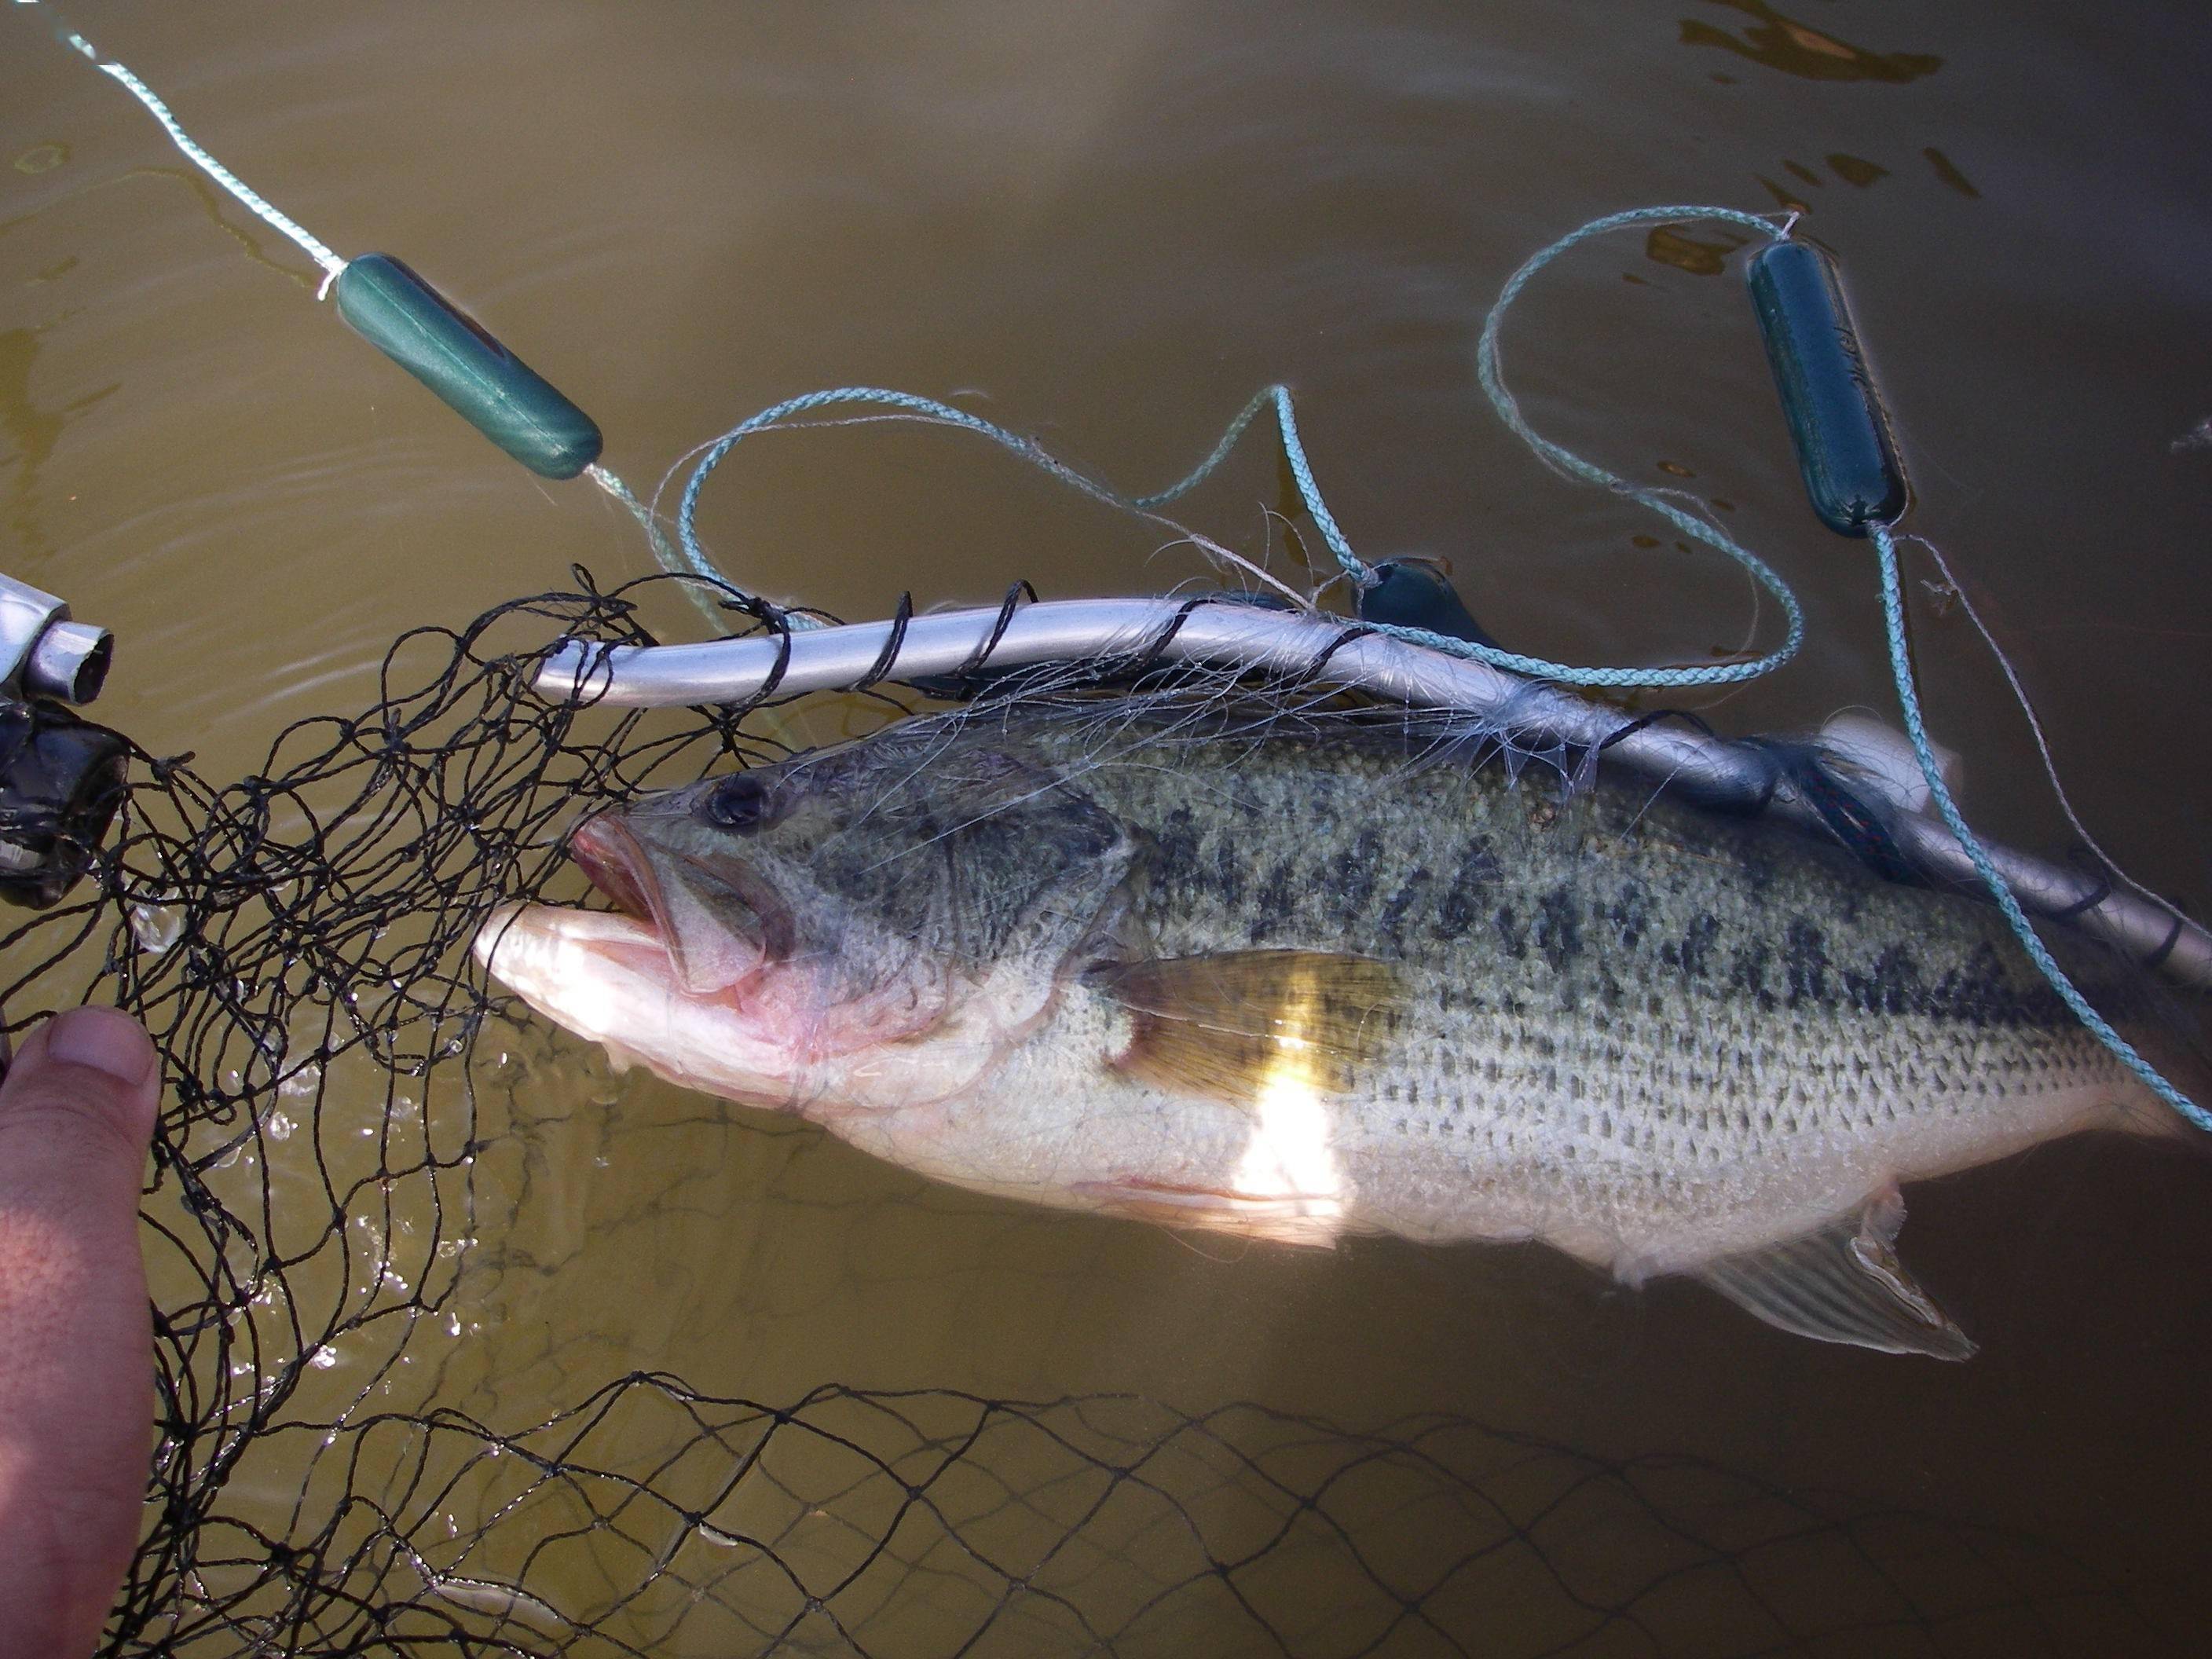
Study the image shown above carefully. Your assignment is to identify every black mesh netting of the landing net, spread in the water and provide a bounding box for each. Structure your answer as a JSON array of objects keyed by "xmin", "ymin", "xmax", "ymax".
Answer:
[{"xmin": 5, "ymin": 593, "xmax": 2134, "ymax": 1657}]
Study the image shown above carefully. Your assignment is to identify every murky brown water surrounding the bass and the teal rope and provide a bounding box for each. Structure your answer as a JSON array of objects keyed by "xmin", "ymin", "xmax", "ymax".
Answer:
[{"xmin": 0, "ymin": 0, "xmax": 2212, "ymax": 1653}]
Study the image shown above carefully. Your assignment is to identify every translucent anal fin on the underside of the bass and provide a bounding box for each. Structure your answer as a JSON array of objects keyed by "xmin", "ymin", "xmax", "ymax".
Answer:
[{"xmin": 1699, "ymin": 1190, "xmax": 1973, "ymax": 1361}]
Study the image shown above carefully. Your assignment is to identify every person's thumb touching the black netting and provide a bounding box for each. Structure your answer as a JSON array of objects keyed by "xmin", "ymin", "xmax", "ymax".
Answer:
[{"xmin": 0, "ymin": 1009, "xmax": 162, "ymax": 1659}]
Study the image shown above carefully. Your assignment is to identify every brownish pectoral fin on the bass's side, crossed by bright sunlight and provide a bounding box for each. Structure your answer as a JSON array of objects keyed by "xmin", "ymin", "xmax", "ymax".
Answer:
[{"xmin": 1090, "ymin": 951, "xmax": 1401, "ymax": 1104}]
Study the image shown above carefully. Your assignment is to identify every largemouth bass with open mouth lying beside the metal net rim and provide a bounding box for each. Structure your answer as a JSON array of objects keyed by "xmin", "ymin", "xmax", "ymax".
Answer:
[{"xmin": 478, "ymin": 712, "xmax": 2163, "ymax": 1358}]
